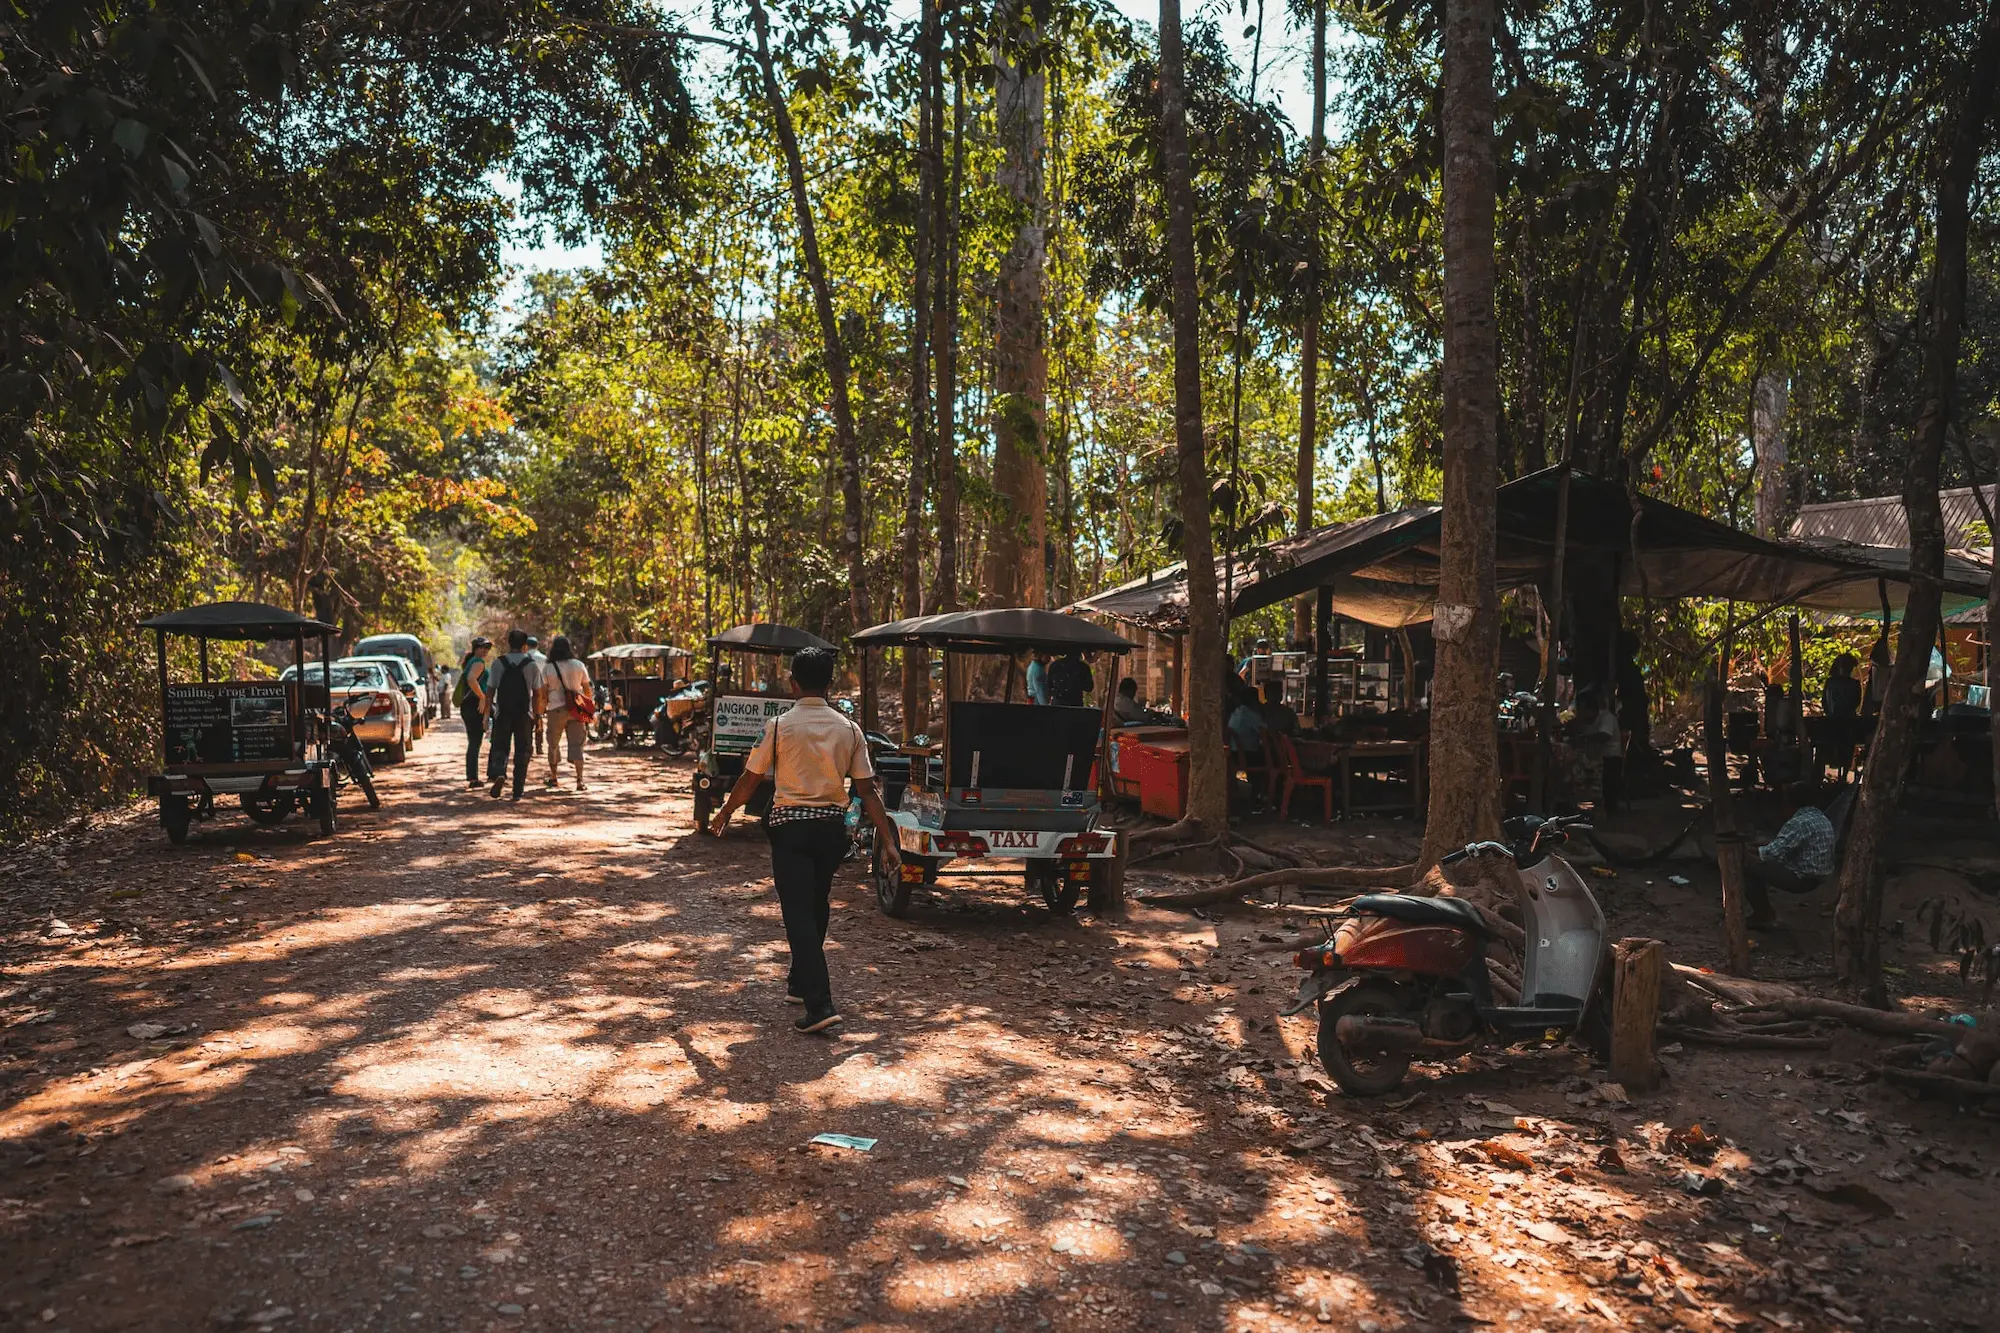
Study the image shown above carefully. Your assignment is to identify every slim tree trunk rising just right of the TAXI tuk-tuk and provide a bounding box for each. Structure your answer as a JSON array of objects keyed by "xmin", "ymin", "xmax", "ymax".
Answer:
[{"xmin": 1160, "ymin": 0, "xmax": 1230, "ymax": 835}]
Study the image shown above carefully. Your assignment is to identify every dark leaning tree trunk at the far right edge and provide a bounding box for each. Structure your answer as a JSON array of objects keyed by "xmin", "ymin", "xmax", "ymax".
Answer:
[{"xmin": 1834, "ymin": 0, "xmax": 2000, "ymax": 1003}]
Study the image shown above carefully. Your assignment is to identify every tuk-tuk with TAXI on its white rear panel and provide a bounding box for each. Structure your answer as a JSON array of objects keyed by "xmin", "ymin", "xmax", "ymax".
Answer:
[{"xmin": 854, "ymin": 608, "xmax": 1132, "ymax": 917}]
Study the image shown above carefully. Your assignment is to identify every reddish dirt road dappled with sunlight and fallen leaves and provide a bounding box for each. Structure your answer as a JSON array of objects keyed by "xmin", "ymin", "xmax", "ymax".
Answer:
[{"xmin": 0, "ymin": 725, "xmax": 1996, "ymax": 1333}]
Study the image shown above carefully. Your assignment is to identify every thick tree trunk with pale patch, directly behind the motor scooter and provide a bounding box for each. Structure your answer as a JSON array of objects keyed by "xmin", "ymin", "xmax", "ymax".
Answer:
[{"xmin": 1418, "ymin": 0, "xmax": 1500, "ymax": 867}]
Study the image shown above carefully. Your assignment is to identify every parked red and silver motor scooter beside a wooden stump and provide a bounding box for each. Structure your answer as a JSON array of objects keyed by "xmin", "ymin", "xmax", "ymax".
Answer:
[{"xmin": 1284, "ymin": 815, "xmax": 1610, "ymax": 1097}]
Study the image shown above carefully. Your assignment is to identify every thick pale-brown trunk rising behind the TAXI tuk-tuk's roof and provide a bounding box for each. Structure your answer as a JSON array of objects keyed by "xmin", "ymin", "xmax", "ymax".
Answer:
[{"xmin": 980, "ymin": 0, "xmax": 1048, "ymax": 606}]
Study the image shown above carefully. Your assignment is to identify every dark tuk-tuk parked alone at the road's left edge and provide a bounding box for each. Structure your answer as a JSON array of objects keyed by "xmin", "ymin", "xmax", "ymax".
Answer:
[{"xmin": 140, "ymin": 602, "xmax": 338, "ymax": 845}]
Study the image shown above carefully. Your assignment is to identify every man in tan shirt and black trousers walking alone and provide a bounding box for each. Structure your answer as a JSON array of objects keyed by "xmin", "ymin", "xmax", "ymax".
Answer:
[{"xmin": 710, "ymin": 648, "xmax": 902, "ymax": 1033}]
